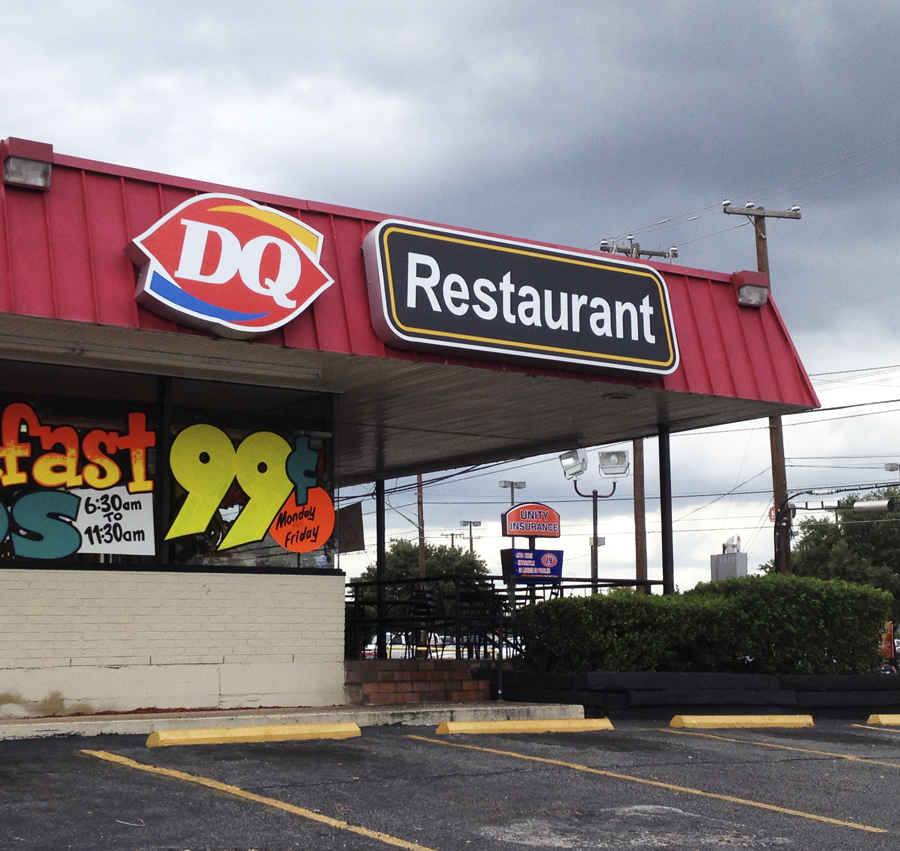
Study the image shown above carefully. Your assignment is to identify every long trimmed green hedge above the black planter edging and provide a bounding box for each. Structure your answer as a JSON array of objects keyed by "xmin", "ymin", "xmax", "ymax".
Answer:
[{"xmin": 517, "ymin": 575, "xmax": 891, "ymax": 674}]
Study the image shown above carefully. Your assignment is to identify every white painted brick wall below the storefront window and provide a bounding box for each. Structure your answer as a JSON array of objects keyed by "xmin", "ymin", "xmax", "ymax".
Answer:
[{"xmin": 0, "ymin": 568, "xmax": 344, "ymax": 711}]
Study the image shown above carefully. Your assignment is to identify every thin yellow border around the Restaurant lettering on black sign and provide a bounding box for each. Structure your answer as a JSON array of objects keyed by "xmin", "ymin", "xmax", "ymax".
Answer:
[{"xmin": 379, "ymin": 225, "xmax": 675, "ymax": 368}]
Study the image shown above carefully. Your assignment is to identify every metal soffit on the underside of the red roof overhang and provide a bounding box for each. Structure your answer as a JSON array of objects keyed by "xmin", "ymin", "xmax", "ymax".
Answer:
[{"xmin": 0, "ymin": 316, "xmax": 802, "ymax": 485}]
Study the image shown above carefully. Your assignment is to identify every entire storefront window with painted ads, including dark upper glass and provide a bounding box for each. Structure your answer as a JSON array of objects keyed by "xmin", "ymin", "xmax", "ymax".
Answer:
[{"xmin": 0, "ymin": 362, "xmax": 337, "ymax": 569}]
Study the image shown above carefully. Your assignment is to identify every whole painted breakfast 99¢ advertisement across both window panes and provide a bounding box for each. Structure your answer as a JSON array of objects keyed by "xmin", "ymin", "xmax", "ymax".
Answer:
[{"xmin": 0, "ymin": 402, "xmax": 335, "ymax": 567}]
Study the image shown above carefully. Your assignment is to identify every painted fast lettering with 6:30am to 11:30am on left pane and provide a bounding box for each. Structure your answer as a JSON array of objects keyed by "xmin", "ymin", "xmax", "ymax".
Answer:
[{"xmin": 0, "ymin": 402, "xmax": 156, "ymax": 560}]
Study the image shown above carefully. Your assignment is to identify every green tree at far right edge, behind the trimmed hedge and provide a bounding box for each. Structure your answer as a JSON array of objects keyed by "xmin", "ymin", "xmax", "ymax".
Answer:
[{"xmin": 764, "ymin": 489, "xmax": 900, "ymax": 621}]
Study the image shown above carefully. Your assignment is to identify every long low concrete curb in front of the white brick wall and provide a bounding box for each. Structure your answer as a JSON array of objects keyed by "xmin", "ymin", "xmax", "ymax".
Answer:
[{"xmin": 0, "ymin": 701, "xmax": 584, "ymax": 740}]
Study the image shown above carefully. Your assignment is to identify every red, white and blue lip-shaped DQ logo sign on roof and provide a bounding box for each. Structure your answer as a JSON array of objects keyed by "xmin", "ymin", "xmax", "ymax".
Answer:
[{"xmin": 129, "ymin": 195, "xmax": 334, "ymax": 338}]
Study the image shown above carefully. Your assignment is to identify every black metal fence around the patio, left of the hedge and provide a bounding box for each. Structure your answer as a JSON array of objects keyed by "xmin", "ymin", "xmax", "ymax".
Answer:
[{"xmin": 344, "ymin": 575, "xmax": 662, "ymax": 659}]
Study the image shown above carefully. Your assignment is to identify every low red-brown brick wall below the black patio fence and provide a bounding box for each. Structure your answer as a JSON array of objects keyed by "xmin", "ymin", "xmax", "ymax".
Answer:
[{"xmin": 344, "ymin": 659, "xmax": 490, "ymax": 704}]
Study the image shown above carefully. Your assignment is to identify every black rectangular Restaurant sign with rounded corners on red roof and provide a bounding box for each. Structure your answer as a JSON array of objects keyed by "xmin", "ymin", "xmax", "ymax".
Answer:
[{"xmin": 363, "ymin": 220, "xmax": 678, "ymax": 374}]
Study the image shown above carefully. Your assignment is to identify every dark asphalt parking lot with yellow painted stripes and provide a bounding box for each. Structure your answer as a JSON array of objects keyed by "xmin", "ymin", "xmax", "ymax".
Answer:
[{"xmin": 0, "ymin": 720, "xmax": 900, "ymax": 851}]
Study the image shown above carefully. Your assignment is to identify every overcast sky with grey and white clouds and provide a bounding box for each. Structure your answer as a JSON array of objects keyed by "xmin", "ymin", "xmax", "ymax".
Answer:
[{"xmin": 0, "ymin": 0, "xmax": 900, "ymax": 589}]
